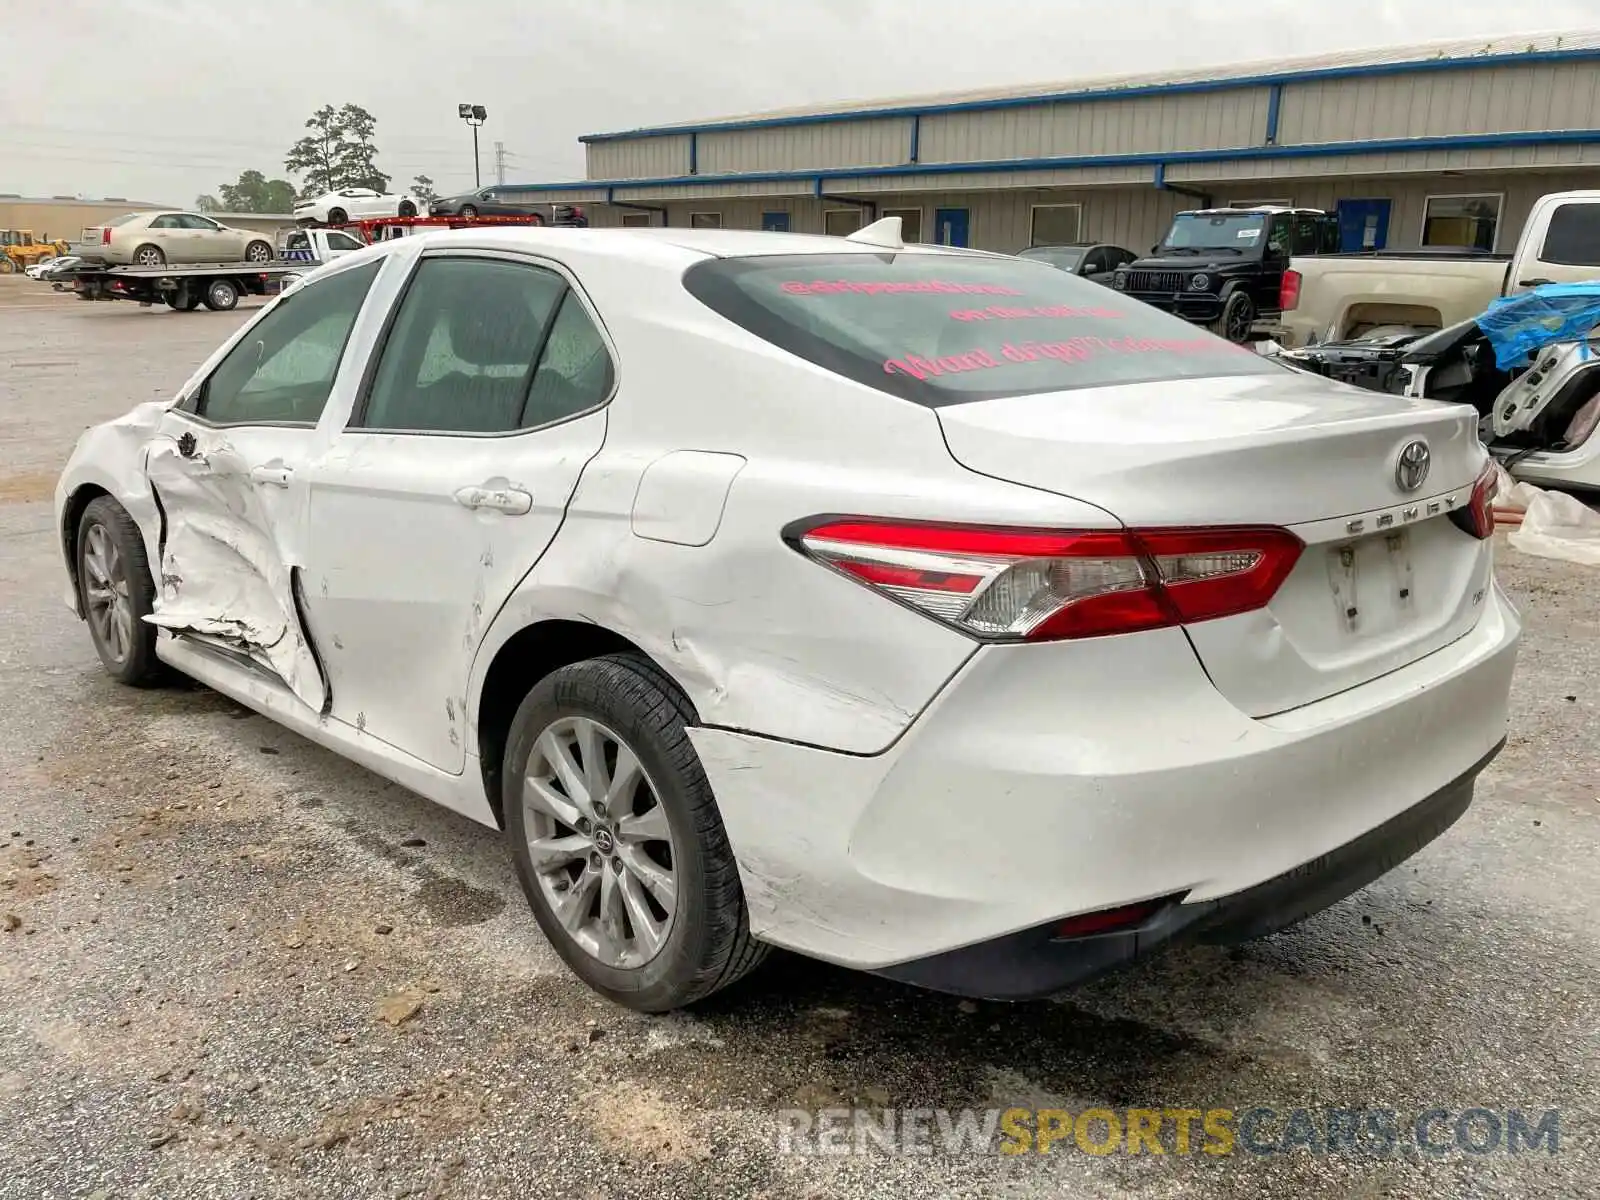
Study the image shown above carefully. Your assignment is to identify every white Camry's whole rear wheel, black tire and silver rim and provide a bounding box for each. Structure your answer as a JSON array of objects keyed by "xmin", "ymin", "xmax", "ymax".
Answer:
[{"xmin": 502, "ymin": 654, "xmax": 766, "ymax": 1013}]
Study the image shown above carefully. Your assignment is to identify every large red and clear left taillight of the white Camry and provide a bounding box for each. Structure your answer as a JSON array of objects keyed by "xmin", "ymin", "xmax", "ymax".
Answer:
[{"xmin": 790, "ymin": 518, "xmax": 1304, "ymax": 642}]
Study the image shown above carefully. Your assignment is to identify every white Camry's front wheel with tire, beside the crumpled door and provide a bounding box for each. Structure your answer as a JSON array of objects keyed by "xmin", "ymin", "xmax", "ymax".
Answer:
[{"xmin": 75, "ymin": 496, "xmax": 166, "ymax": 688}]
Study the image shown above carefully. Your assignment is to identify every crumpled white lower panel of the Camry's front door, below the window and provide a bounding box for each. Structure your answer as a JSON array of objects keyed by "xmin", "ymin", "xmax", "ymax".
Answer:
[{"xmin": 146, "ymin": 411, "xmax": 328, "ymax": 712}]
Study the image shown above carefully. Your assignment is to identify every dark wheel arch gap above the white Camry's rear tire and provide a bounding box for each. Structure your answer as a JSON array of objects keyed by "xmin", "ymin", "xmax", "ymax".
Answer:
[{"xmin": 475, "ymin": 618, "xmax": 698, "ymax": 829}]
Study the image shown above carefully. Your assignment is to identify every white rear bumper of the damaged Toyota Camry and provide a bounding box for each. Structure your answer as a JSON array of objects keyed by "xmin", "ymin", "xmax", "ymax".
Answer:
[{"xmin": 691, "ymin": 589, "xmax": 1520, "ymax": 994}]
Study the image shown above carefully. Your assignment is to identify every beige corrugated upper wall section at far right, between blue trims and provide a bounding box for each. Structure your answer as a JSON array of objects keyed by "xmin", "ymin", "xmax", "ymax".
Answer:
[{"xmin": 1278, "ymin": 62, "xmax": 1600, "ymax": 146}]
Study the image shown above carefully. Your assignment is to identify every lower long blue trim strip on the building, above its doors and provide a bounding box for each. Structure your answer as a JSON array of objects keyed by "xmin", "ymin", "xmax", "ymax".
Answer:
[{"xmin": 501, "ymin": 130, "xmax": 1600, "ymax": 192}]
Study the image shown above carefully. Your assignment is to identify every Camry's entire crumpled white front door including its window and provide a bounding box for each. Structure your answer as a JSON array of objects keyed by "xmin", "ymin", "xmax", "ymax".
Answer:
[{"xmin": 144, "ymin": 261, "xmax": 381, "ymax": 712}]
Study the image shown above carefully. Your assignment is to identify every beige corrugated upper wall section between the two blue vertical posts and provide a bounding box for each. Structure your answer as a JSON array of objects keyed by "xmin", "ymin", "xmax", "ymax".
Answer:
[{"xmin": 918, "ymin": 88, "xmax": 1267, "ymax": 163}]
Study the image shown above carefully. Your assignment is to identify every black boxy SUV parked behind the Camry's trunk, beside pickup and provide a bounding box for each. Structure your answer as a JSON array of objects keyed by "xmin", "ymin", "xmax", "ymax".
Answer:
[{"xmin": 1110, "ymin": 208, "xmax": 1339, "ymax": 344}]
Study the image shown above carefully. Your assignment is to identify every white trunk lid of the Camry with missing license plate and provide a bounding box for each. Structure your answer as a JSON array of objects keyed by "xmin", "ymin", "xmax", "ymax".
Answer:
[{"xmin": 938, "ymin": 371, "xmax": 1491, "ymax": 717}]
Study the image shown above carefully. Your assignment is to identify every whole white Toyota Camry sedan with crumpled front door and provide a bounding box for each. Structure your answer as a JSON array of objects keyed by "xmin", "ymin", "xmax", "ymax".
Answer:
[{"xmin": 56, "ymin": 219, "xmax": 1520, "ymax": 1011}]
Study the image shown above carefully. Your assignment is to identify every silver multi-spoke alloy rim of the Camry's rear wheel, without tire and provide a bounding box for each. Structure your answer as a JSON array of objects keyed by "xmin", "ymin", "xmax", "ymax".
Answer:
[{"xmin": 522, "ymin": 717, "xmax": 678, "ymax": 968}]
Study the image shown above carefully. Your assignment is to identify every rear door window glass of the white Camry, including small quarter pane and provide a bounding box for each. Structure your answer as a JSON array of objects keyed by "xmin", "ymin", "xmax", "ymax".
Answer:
[{"xmin": 354, "ymin": 258, "xmax": 611, "ymax": 434}]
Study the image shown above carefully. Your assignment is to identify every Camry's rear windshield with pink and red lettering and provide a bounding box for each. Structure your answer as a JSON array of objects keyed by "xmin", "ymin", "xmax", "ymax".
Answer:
[{"xmin": 683, "ymin": 251, "xmax": 1283, "ymax": 408}]
